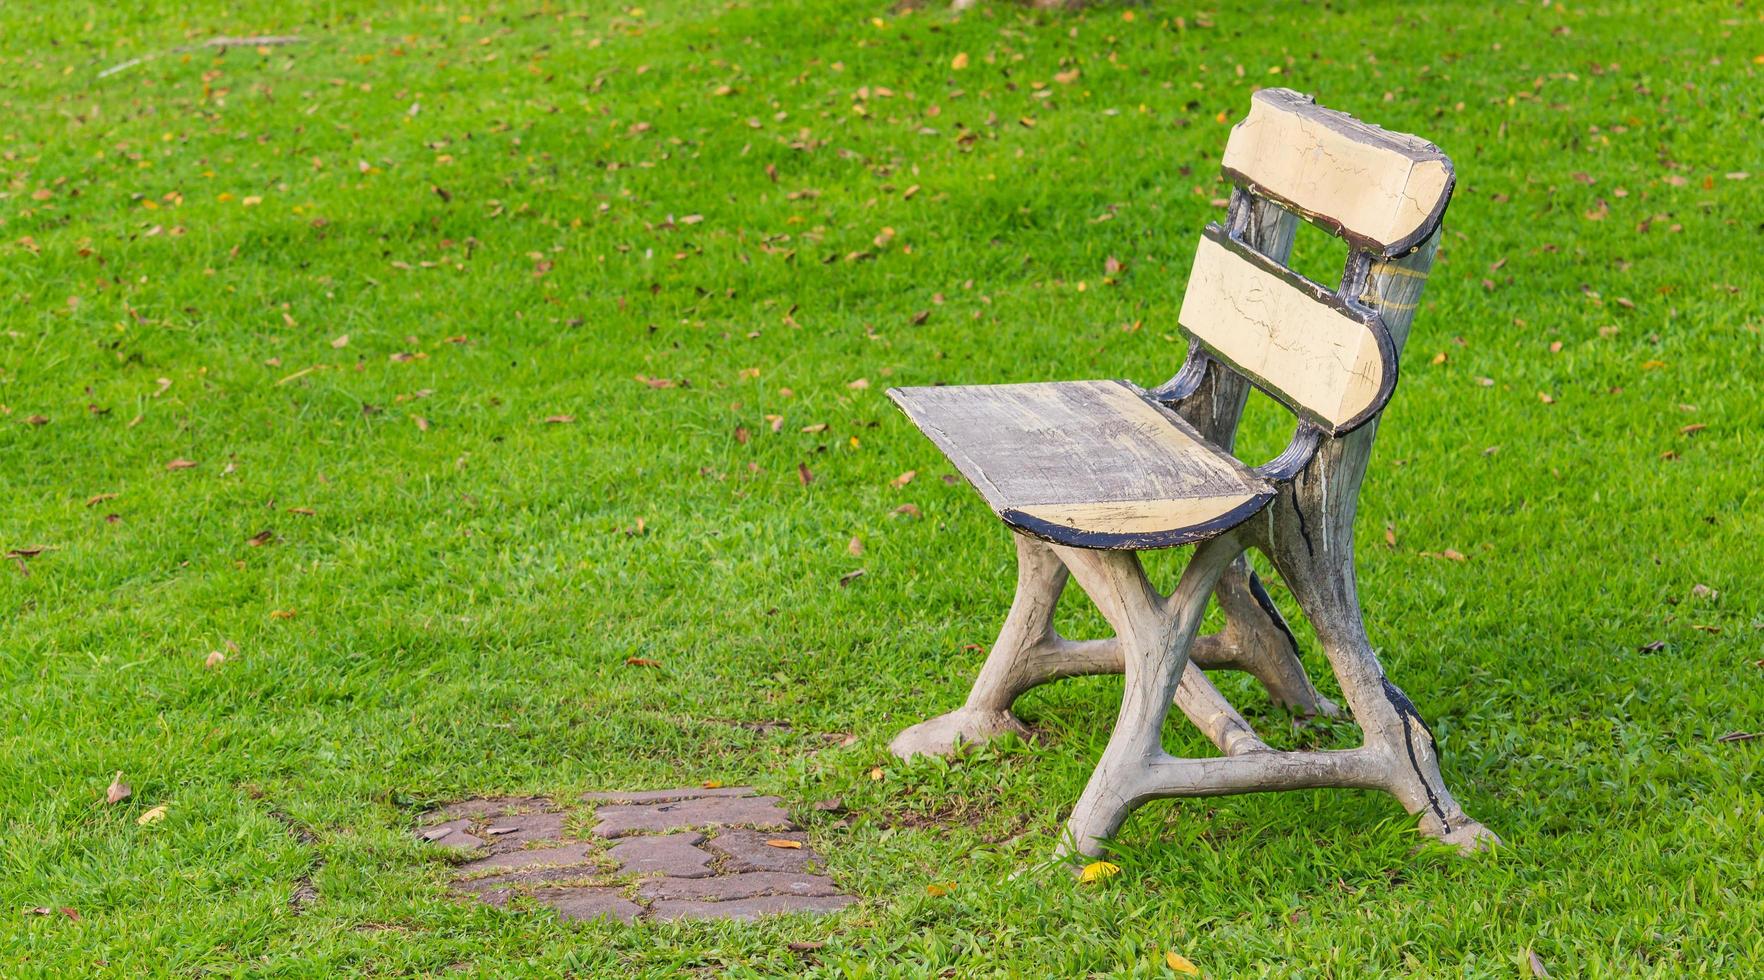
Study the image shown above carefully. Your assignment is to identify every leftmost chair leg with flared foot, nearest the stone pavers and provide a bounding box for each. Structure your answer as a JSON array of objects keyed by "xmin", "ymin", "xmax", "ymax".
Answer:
[{"xmin": 889, "ymin": 534, "xmax": 1120, "ymax": 760}]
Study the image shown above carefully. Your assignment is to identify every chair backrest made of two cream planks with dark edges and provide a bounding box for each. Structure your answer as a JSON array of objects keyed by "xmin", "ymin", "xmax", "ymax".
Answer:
[{"xmin": 1178, "ymin": 88, "xmax": 1454, "ymax": 435}]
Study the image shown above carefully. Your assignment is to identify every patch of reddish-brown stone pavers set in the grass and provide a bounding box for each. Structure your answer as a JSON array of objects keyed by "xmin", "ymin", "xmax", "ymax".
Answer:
[{"xmin": 416, "ymin": 786, "xmax": 856, "ymax": 922}]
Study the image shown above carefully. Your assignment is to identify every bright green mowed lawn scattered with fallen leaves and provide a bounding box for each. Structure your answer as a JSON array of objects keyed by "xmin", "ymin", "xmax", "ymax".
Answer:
[{"xmin": 0, "ymin": 0, "xmax": 1764, "ymax": 976}]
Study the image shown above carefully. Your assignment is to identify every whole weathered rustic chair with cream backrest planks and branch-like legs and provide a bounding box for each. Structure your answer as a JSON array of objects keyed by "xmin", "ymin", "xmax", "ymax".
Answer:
[{"xmin": 889, "ymin": 88, "xmax": 1498, "ymax": 855}]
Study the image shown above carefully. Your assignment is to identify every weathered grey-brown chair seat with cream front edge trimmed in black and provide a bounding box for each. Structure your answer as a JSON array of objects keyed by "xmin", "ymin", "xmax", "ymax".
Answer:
[{"xmin": 889, "ymin": 381, "xmax": 1275, "ymax": 550}]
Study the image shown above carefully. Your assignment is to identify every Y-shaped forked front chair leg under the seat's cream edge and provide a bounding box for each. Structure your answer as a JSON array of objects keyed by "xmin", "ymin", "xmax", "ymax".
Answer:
[{"xmin": 1055, "ymin": 536, "xmax": 1247, "ymax": 857}]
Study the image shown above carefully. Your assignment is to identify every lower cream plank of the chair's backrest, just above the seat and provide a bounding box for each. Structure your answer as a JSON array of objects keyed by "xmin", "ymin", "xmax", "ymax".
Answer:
[{"xmin": 1177, "ymin": 226, "xmax": 1397, "ymax": 432}]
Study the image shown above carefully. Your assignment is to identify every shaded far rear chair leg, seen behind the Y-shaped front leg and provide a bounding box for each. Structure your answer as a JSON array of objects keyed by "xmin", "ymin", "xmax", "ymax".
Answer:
[{"xmin": 1192, "ymin": 555, "xmax": 1341, "ymax": 717}]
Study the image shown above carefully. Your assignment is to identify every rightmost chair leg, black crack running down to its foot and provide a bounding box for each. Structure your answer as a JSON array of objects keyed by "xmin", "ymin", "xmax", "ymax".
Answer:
[{"xmin": 1268, "ymin": 494, "xmax": 1499, "ymax": 853}]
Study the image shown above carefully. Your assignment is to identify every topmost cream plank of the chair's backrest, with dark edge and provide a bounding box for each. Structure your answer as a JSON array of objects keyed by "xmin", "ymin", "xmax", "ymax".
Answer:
[{"xmin": 1222, "ymin": 88, "xmax": 1454, "ymax": 256}]
